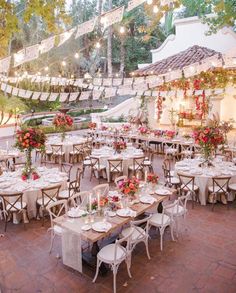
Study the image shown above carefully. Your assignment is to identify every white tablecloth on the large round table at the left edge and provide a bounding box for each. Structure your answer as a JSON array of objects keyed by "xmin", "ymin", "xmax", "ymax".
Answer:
[{"xmin": 0, "ymin": 167, "xmax": 67, "ymax": 218}]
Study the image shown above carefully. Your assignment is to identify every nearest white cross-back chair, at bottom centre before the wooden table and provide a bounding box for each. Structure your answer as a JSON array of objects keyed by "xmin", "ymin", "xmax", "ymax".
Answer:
[{"xmin": 93, "ymin": 229, "xmax": 133, "ymax": 293}]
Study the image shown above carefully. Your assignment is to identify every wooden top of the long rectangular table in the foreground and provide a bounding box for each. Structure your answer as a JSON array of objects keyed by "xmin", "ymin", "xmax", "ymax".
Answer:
[{"xmin": 53, "ymin": 190, "xmax": 170, "ymax": 243}]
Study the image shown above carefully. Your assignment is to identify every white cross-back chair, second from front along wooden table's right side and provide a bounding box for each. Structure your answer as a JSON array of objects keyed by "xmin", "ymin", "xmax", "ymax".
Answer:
[{"xmin": 121, "ymin": 215, "xmax": 151, "ymax": 259}]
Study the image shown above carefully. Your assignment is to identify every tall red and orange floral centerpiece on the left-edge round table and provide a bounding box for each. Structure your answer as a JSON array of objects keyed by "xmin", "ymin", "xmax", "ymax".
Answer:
[{"xmin": 15, "ymin": 128, "xmax": 46, "ymax": 179}]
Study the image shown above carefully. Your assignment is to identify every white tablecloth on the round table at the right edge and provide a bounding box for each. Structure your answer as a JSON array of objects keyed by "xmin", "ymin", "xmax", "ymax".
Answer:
[{"xmin": 175, "ymin": 159, "xmax": 236, "ymax": 205}]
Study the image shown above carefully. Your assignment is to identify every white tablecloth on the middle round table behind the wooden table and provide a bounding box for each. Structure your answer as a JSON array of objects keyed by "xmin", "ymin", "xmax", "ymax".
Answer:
[{"xmin": 92, "ymin": 147, "xmax": 143, "ymax": 182}]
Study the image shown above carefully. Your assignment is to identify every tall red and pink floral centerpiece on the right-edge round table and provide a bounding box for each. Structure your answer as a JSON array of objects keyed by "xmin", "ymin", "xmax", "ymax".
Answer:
[{"xmin": 193, "ymin": 125, "xmax": 224, "ymax": 164}]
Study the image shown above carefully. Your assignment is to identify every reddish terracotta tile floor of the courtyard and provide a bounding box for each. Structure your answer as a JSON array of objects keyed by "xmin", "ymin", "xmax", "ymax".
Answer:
[{"xmin": 0, "ymin": 155, "xmax": 236, "ymax": 293}]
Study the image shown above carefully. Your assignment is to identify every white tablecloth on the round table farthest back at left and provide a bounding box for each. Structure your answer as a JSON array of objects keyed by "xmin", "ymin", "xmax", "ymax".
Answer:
[{"xmin": 46, "ymin": 135, "xmax": 87, "ymax": 162}]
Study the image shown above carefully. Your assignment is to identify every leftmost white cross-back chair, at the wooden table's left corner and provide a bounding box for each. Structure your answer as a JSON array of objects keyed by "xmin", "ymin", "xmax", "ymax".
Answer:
[{"xmin": 46, "ymin": 199, "xmax": 68, "ymax": 253}]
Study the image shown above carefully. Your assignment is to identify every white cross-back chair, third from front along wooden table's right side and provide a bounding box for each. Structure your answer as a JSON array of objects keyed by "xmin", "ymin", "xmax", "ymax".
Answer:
[{"xmin": 149, "ymin": 201, "xmax": 175, "ymax": 251}]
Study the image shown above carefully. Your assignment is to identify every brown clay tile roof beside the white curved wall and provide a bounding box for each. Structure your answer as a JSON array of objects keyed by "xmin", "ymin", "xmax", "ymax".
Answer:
[{"xmin": 134, "ymin": 45, "xmax": 222, "ymax": 76}]
